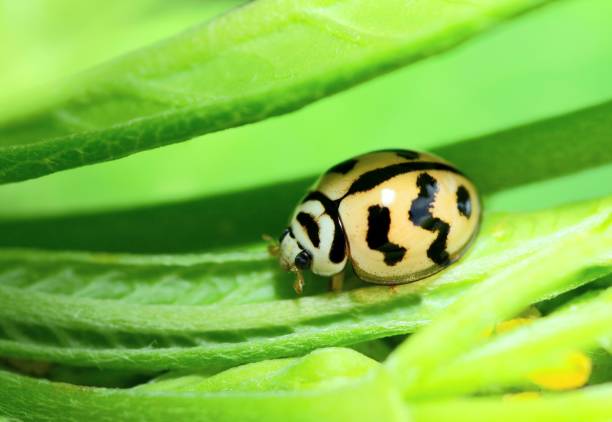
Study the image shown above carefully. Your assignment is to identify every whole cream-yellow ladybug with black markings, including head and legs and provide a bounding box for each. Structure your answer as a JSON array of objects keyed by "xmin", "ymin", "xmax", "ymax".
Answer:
[{"xmin": 277, "ymin": 150, "xmax": 481, "ymax": 293}]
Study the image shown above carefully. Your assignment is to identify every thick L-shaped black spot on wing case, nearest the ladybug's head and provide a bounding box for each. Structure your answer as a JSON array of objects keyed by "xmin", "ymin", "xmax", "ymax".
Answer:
[{"xmin": 366, "ymin": 205, "xmax": 406, "ymax": 265}]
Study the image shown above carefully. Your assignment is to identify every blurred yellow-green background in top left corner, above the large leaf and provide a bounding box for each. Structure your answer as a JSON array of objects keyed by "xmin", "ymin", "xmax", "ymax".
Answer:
[{"xmin": 0, "ymin": 0, "xmax": 240, "ymax": 121}]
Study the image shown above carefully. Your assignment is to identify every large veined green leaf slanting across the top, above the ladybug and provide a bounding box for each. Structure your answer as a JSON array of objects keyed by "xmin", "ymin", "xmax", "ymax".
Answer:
[{"xmin": 0, "ymin": 0, "xmax": 546, "ymax": 183}]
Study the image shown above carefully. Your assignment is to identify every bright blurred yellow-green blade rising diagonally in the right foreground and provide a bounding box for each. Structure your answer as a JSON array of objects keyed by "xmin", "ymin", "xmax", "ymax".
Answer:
[{"xmin": 386, "ymin": 198, "xmax": 612, "ymax": 397}]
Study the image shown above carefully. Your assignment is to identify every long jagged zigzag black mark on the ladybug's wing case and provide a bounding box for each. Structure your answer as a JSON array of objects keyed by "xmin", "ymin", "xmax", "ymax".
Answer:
[{"xmin": 408, "ymin": 173, "xmax": 450, "ymax": 265}]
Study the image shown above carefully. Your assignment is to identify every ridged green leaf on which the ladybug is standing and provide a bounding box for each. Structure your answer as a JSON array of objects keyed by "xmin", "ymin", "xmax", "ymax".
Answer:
[{"xmin": 0, "ymin": 199, "xmax": 612, "ymax": 371}]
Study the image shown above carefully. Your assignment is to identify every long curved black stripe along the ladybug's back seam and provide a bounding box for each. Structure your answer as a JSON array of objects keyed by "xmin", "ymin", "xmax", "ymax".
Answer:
[{"xmin": 338, "ymin": 161, "xmax": 461, "ymax": 202}]
